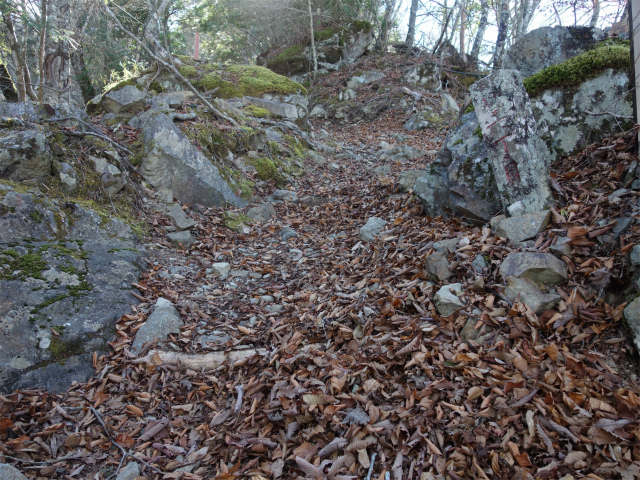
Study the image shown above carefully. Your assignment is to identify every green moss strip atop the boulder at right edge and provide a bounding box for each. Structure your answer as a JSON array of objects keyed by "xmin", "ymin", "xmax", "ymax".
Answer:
[{"xmin": 524, "ymin": 45, "xmax": 631, "ymax": 97}]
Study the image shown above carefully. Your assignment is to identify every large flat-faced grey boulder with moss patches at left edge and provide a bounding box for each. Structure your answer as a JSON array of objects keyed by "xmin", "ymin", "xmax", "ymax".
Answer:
[{"xmin": 0, "ymin": 183, "xmax": 142, "ymax": 392}]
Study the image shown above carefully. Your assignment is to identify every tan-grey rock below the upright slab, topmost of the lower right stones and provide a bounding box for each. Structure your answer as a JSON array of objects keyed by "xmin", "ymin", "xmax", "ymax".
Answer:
[{"xmin": 499, "ymin": 252, "xmax": 567, "ymax": 285}]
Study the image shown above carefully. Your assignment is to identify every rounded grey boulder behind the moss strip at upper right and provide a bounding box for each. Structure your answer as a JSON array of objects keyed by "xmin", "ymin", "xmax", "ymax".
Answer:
[{"xmin": 503, "ymin": 27, "xmax": 604, "ymax": 77}]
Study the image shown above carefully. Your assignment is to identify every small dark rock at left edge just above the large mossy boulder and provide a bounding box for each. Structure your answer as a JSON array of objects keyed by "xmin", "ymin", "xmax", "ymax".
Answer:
[{"xmin": 0, "ymin": 129, "xmax": 52, "ymax": 182}]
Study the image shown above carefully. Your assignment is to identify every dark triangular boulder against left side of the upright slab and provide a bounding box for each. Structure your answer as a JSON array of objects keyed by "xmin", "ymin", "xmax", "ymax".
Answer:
[{"xmin": 414, "ymin": 112, "xmax": 501, "ymax": 224}]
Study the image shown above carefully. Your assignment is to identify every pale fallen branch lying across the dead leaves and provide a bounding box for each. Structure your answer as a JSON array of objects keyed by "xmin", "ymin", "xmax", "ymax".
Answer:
[{"xmin": 133, "ymin": 348, "xmax": 267, "ymax": 371}]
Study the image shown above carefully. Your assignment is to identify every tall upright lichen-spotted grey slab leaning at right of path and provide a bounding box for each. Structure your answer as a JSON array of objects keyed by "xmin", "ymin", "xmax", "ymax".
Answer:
[{"xmin": 470, "ymin": 70, "xmax": 553, "ymax": 213}]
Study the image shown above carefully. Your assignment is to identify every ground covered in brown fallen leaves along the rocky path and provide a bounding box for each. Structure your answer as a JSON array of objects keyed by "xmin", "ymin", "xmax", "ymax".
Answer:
[{"xmin": 0, "ymin": 56, "xmax": 640, "ymax": 480}]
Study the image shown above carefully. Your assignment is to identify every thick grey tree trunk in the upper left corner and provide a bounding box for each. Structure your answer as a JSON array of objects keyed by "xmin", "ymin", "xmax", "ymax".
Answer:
[{"xmin": 43, "ymin": 0, "xmax": 84, "ymax": 108}]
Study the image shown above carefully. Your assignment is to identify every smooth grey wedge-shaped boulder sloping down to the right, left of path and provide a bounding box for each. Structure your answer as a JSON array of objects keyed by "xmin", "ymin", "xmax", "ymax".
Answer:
[{"xmin": 131, "ymin": 112, "xmax": 246, "ymax": 207}]
